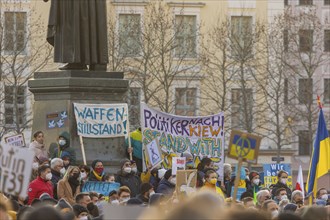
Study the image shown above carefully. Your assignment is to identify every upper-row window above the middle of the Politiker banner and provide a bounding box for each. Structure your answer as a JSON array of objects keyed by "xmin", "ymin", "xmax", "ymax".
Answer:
[{"xmin": 175, "ymin": 15, "xmax": 197, "ymax": 58}]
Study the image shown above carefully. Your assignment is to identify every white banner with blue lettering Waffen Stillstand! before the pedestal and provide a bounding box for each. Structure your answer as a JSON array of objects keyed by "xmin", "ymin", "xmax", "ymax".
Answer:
[{"xmin": 73, "ymin": 103, "xmax": 129, "ymax": 138}]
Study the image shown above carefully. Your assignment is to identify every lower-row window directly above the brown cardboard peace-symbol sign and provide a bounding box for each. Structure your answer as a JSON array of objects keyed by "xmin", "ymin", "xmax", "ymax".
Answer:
[{"xmin": 231, "ymin": 89, "xmax": 253, "ymax": 129}]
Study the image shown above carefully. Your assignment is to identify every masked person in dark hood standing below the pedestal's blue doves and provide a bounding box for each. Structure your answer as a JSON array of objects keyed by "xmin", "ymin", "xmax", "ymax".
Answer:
[{"xmin": 51, "ymin": 131, "xmax": 76, "ymax": 165}]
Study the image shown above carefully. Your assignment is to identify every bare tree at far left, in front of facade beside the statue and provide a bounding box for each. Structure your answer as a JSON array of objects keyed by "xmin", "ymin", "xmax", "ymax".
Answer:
[{"xmin": 0, "ymin": 2, "xmax": 52, "ymax": 141}]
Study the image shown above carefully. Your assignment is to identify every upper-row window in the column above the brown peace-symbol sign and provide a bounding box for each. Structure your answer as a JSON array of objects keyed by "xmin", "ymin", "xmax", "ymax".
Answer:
[{"xmin": 231, "ymin": 16, "xmax": 253, "ymax": 57}]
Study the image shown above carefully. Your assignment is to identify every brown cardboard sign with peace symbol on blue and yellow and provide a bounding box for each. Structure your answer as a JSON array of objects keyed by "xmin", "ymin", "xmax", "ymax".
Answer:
[{"xmin": 228, "ymin": 130, "xmax": 261, "ymax": 163}]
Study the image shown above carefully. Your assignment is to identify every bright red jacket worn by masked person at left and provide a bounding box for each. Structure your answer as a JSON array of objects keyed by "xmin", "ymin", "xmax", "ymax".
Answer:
[{"xmin": 28, "ymin": 176, "xmax": 54, "ymax": 205}]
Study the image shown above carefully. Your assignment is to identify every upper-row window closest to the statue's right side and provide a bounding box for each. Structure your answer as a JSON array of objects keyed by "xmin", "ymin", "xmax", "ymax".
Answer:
[{"xmin": 119, "ymin": 14, "xmax": 141, "ymax": 57}]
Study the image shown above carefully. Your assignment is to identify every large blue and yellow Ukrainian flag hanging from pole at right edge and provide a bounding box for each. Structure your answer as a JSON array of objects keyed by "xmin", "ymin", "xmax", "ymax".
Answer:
[{"xmin": 306, "ymin": 107, "xmax": 330, "ymax": 197}]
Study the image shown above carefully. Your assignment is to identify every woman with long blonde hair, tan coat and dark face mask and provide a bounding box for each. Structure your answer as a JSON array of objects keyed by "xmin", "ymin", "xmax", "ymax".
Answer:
[{"xmin": 57, "ymin": 166, "xmax": 80, "ymax": 205}]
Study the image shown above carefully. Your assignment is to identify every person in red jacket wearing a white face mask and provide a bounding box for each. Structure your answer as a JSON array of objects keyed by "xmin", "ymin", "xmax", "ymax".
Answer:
[{"xmin": 28, "ymin": 165, "xmax": 54, "ymax": 205}]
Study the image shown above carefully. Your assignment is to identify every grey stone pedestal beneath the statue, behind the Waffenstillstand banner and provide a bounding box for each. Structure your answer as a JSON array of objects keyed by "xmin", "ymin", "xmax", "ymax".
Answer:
[{"xmin": 28, "ymin": 70, "xmax": 128, "ymax": 172}]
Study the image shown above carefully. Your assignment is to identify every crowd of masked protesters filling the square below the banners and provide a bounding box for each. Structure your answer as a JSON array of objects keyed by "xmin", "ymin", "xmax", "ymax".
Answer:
[{"xmin": 0, "ymin": 129, "xmax": 330, "ymax": 220}]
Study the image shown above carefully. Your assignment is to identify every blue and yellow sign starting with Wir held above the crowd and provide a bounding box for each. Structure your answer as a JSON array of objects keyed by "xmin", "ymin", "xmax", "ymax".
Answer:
[{"xmin": 263, "ymin": 163, "xmax": 292, "ymax": 188}]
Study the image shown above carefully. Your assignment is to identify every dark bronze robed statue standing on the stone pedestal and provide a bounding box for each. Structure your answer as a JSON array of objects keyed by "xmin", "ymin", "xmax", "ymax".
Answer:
[{"xmin": 44, "ymin": 0, "xmax": 108, "ymax": 70}]
